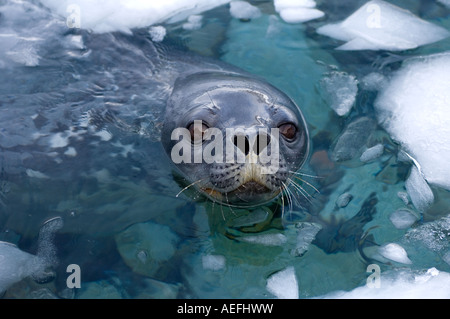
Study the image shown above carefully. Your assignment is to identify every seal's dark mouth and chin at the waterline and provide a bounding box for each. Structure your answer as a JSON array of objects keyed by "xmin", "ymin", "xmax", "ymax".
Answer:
[{"xmin": 202, "ymin": 180, "xmax": 280, "ymax": 207}]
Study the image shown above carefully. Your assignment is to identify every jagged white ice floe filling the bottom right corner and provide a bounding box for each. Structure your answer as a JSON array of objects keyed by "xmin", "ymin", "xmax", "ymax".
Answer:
[{"xmin": 321, "ymin": 268, "xmax": 450, "ymax": 299}]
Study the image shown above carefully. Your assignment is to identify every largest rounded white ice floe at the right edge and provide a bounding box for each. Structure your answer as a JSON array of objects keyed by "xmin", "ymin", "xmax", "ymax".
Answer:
[{"xmin": 375, "ymin": 52, "xmax": 450, "ymax": 190}]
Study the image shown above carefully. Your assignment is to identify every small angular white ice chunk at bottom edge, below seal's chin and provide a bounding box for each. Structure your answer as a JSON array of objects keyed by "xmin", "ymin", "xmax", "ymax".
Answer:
[{"xmin": 266, "ymin": 266, "xmax": 299, "ymax": 299}]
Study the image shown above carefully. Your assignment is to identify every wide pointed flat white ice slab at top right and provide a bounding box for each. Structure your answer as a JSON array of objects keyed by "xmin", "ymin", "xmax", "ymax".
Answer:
[{"xmin": 317, "ymin": 0, "xmax": 450, "ymax": 51}]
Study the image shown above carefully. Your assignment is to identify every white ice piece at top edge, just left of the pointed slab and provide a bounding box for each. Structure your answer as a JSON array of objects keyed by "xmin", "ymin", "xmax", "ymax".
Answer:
[{"xmin": 274, "ymin": 0, "xmax": 325, "ymax": 23}]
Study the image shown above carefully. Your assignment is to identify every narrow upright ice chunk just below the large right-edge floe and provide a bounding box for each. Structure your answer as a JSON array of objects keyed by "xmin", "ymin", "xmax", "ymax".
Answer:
[{"xmin": 405, "ymin": 166, "xmax": 434, "ymax": 212}]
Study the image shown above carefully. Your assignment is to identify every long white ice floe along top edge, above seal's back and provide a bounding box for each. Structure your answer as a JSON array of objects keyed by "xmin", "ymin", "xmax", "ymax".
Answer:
[{"xmin": 41, "ymin": 0, "xmax": 230, "ymax": 33}]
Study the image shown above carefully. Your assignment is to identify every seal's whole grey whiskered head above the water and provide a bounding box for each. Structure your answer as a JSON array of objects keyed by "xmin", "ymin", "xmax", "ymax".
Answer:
[{"xmin": 162, "ymin": 71, "xmax": 309, "ymax": 207}]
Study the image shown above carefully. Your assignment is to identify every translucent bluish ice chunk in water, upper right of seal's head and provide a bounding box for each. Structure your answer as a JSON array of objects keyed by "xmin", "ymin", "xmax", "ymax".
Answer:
[{"xmin": 320, "ymin": 71, "xmax": 358, "ymax": 116}]
